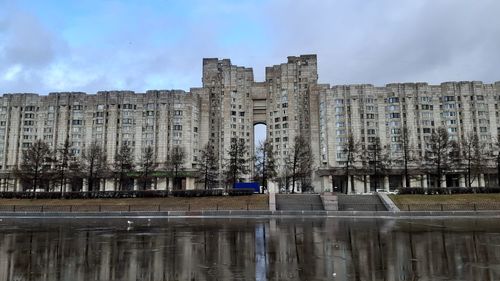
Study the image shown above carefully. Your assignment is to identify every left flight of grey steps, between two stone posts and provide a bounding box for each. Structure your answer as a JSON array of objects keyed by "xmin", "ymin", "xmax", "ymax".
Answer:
[{"xmin": 276, "ymin": 194, "xmax": 324, "ymax": 211}]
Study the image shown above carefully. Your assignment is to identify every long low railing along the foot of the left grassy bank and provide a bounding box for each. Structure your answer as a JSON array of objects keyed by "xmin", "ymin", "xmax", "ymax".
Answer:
[{"xmin": 0, "ymin": 203, "xmax": 269, "ymax": 213}]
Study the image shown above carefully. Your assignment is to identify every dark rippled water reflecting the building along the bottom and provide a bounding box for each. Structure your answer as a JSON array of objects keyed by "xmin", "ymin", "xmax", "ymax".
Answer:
[{"xmin": 0, "ymin": 219, "xmax": 500, "ymax": 281}]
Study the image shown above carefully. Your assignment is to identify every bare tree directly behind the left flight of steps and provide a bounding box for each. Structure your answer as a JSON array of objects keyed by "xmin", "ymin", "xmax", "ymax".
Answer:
[{"xmin": 286, "ymin": 135, "xmax": 314, "ymax": 193}]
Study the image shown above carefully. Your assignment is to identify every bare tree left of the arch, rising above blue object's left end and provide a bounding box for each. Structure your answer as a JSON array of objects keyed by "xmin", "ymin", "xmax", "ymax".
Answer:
[{"xmin": 225, "ymin": 138, "xmax": 250, "ymax": 188}]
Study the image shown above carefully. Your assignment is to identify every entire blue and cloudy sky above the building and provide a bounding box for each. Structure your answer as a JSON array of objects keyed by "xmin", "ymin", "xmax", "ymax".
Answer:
[{"xmin": 0, "ymin": 0, "xmax": 500, "ymax": 94}]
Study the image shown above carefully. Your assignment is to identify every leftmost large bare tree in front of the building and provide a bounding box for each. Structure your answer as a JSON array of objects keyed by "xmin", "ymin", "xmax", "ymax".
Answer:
[{"xmin": 16, "ymin": 139, "xmax": 54, "ymax": 197}]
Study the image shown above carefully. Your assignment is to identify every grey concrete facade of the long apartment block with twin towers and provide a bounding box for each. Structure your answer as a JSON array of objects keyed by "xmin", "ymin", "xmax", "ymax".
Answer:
[{"xmin": 0, "ymin": 55, "xmax": 500, "ymax": 193}]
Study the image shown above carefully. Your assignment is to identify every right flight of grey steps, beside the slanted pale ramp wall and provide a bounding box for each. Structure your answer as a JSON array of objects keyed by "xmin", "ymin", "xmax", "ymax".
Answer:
[{"xmin": 338, "ymin": 195, "xmax": 387, "ymax": 211}]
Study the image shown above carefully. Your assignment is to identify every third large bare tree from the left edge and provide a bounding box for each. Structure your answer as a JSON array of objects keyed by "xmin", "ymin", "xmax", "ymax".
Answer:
[{"xmin": 81, "ymin": 142, "xmax": 108, "ymax": 191}]
